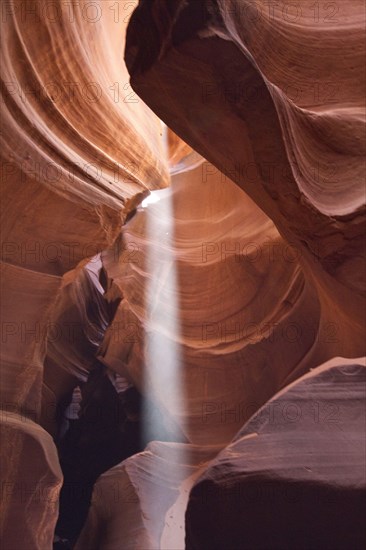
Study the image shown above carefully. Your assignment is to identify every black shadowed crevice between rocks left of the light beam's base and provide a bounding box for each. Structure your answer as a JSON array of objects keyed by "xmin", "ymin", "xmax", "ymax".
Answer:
[{"xmin": 53, "ymin": 362, "xmax": 184, "ymax": 550}]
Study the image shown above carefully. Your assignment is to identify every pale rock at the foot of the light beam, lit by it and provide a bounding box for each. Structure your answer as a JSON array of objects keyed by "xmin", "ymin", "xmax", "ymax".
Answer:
[{"xmin": 76, "ymin": 441, "xmax": 219, "ymax": 550}]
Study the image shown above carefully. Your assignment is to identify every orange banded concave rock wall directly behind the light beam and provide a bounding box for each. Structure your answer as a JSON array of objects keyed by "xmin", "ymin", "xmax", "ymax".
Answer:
[{"xmin": 99, "ymin": 161, "xmax": 322, "ymax": 444}]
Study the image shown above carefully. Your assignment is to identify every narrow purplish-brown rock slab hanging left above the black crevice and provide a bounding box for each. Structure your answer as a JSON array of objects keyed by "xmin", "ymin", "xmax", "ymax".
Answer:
[{"xmin": 40, "ymin": 257, "xmax": 112, "ymax": 435}]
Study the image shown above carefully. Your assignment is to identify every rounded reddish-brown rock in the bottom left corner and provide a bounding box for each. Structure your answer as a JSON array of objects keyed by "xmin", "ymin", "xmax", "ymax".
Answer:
[{"xmin": 0, "ymin": 411, "xmax": 62, "ymax": 550}]
